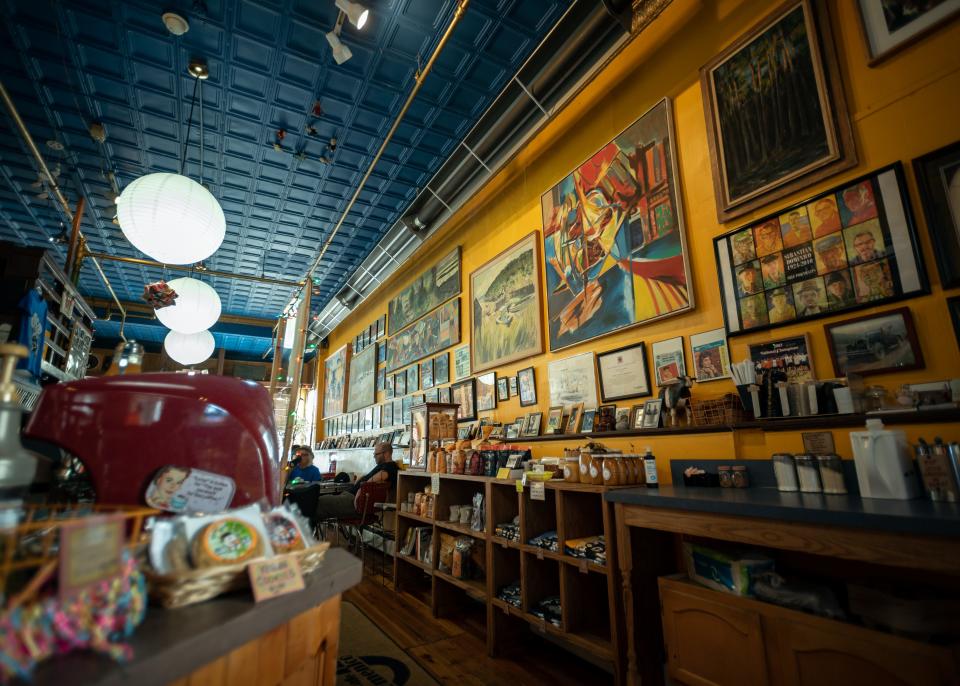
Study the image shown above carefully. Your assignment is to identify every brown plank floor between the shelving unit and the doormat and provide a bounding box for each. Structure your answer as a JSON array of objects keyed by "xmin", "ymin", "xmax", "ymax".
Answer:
[{"xmin": 343, "ymin": 570, "xmax": 613, "ymax": 686}]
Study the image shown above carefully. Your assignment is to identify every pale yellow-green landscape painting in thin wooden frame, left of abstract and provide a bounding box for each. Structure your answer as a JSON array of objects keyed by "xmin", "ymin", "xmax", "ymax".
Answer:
[{"xmin": 470, "ymin": 231, "xmax": 543, "ymax": 373}]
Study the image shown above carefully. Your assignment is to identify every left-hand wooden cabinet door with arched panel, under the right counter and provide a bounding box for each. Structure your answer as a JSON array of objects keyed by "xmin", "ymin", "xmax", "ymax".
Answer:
[{"xmin": 660, "ymin": 583, "xmax": 768, "ymax": 686}]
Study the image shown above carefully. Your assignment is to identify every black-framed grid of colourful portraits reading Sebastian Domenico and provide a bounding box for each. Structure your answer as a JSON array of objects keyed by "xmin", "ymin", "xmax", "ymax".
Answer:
[{"xmin": 714, "ymin": 167, "xmax": 929, "ymax": 336}]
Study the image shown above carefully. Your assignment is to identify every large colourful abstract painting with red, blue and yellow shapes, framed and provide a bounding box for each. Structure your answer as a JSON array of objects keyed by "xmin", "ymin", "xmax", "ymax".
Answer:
[{"xmin": 540, "ymin": 99, "xmax": 693, "ymax": 350}]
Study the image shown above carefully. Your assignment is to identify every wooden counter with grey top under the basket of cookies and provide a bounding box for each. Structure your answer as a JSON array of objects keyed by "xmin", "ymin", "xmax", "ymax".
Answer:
[{"xmin": 32, "ymin": 548, "xmax": 361, "ymax": 686}]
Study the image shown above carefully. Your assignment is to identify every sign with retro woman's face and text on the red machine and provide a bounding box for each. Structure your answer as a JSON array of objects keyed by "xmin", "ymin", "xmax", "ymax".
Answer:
[{"xmin": 144, "ymin": 465, "xmax": 236, "ymax": 514}]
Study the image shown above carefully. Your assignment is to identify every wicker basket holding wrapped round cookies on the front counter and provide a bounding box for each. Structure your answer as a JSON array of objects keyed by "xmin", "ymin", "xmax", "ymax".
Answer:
[{"xmin": 143, "ymin": 541, "xmax": 330, "ymax": 608}]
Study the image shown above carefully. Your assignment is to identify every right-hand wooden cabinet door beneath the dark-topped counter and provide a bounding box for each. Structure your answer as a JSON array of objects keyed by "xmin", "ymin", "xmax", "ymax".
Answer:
[{"xmin": 765, "ymin": 617, "xmax": 960, "ymax": 686}]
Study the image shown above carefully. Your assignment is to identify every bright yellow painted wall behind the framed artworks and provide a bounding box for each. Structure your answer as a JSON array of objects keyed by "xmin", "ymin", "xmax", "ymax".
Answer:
[{"xmin": 320, "ymin": 0, "xmax": 960, "ymax": 478}]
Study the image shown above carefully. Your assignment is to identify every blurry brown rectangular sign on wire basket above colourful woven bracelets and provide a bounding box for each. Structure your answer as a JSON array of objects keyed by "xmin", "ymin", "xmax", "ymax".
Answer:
[{"xmin": 60, "ymin": 516, "xmax": 124, "ymax": 599}]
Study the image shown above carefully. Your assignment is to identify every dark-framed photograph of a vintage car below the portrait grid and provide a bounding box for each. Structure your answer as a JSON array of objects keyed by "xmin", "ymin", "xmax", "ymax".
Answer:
[{"xmin": 823, "ymin": 307, "xmax": 923, "ymax": 376}]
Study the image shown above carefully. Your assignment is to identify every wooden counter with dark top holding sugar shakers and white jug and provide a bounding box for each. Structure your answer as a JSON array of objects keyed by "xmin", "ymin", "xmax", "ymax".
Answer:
[{"xmin": 605, "ymin": 487, "xmax": 960, "ymax": 686}]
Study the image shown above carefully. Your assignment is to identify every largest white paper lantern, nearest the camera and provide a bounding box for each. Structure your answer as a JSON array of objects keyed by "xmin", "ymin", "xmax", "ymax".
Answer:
[{"xmin": 117, "ymin": 173, "xmax": 227, "ymax": 264}]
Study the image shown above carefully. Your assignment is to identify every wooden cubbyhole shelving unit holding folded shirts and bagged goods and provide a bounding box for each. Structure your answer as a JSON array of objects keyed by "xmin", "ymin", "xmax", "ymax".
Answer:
[{"xmin": 394, "ymin": 471, "xmax": 628, "ymax": 683}]
